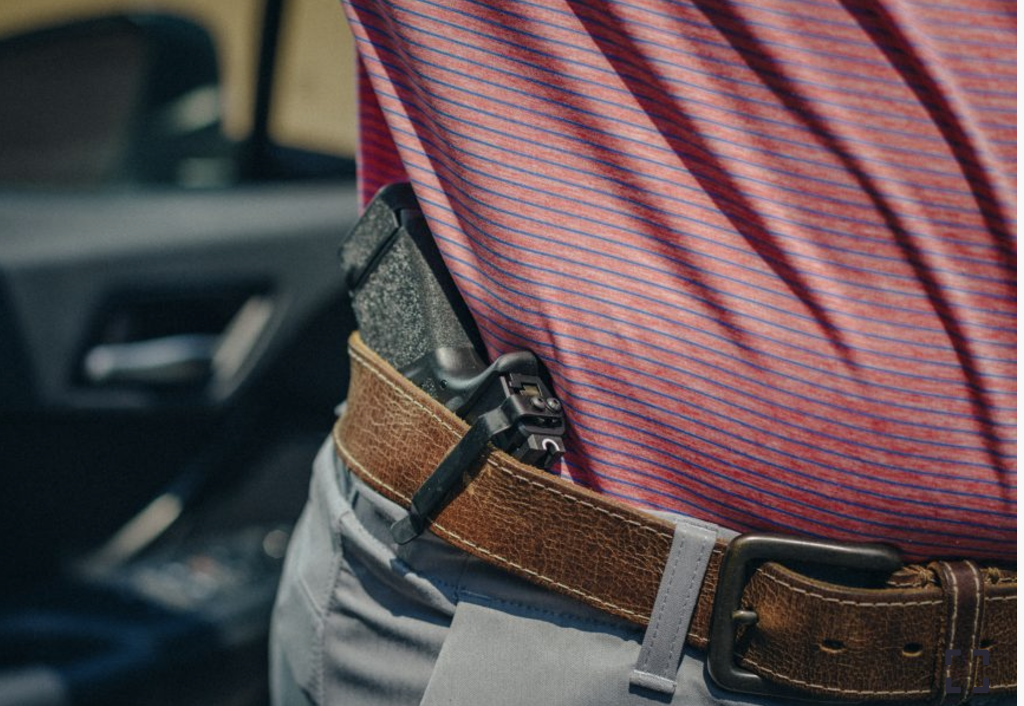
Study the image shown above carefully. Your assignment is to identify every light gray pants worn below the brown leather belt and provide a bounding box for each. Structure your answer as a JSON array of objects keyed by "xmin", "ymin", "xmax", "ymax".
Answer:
[{"xmin": 270, "ymin": 443, "xmax": 1007, "ymax": 706}]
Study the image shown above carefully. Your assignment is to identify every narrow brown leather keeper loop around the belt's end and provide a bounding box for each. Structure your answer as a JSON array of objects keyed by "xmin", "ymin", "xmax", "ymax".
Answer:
[{"xmin": 929, "ymin": 562, "xmax": 986, "ymax": 706}]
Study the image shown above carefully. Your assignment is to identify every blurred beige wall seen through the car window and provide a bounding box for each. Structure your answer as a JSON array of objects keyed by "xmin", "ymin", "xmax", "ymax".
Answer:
[{"xmin": 0, "ymin": 0, "xmax": 355, "ymax": 155}]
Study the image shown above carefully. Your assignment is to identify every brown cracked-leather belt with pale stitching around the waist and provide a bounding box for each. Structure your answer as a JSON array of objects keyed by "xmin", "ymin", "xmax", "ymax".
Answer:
[{"xmin": 334, "ymin": 334, "xmax": 1017, "ymax": 704}]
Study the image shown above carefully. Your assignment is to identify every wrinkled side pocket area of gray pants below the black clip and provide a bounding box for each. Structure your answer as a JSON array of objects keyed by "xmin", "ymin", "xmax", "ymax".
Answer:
[{"xmin": 319, "ymin": 450, "xmax": 463, "ymax": 706}]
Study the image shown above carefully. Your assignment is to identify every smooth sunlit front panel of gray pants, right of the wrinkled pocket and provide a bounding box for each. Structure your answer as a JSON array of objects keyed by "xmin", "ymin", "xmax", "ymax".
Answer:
[{"xmin": 411, "ymin": 590, "xmax": 765, "ymax": 706}]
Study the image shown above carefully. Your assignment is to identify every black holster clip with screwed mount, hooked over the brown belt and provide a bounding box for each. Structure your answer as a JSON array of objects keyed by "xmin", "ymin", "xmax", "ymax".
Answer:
[{"xmin": 391, "ymin": 351, "xmax": 565, "ymax": 544}]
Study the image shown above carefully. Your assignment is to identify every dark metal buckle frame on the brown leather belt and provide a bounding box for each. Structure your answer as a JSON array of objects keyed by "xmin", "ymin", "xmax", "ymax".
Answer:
[{"xmin": 708, "ymin": 534, "xmax": 903, "ymax": 699}]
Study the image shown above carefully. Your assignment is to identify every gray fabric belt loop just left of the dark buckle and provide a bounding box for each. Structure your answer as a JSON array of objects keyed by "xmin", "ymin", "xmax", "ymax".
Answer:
[{"xmin": 630, "ymin": 517, "xmax": 717, "ymax": 695}]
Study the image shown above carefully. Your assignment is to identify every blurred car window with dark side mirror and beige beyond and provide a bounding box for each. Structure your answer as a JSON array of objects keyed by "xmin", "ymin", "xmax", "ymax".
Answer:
[{"xmin": 0, "ymin": 0, "xmax": 355, "ymax": 186}]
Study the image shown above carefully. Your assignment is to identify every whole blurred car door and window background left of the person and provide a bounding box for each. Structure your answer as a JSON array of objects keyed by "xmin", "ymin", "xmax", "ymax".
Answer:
[{"xmin": 0, "ymin": 0, "xmax": 357, "ymax": 705}]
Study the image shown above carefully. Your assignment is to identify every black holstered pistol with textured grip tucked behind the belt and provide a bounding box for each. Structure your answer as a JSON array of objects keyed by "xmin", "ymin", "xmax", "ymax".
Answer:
[{"xmin": 339, "ymin": 183, "xmax": 565, "ymax": 469}]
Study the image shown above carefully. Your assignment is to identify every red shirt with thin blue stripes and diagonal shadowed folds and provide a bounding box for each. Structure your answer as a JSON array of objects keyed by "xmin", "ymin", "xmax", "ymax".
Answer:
[{"xmin": 339, "ymin": 0, "xmax": 1017, "ymax": 559}]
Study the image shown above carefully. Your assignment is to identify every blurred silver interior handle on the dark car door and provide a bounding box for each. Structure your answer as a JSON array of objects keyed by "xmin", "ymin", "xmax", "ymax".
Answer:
[{"xmin": 82, "ymin": 334, "xmax": 220, "ymax": 386}]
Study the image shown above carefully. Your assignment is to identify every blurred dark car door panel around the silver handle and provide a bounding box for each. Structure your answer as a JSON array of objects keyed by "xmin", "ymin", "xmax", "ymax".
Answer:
[{"xmin": 0, "ymin": 182, "xmax": 357, "ymax": 574}]
